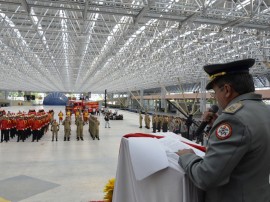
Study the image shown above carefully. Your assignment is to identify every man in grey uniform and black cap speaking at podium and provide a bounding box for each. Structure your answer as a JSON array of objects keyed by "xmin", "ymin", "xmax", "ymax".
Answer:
[{"xmin": 177, "ymin": 59, "xmax": 270, "ymax": 202}]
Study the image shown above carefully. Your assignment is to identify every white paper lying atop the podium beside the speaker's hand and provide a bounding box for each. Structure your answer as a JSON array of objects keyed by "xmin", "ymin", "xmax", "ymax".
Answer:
[{"xmin": 158, "ymin": 137, "xmax": 205, "ymax": 157}]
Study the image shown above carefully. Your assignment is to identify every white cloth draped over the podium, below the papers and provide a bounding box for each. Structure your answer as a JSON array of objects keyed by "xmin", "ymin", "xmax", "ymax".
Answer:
[{"xmin": 113, "ymin": 134, "xmax": 204, "ymax": 202}]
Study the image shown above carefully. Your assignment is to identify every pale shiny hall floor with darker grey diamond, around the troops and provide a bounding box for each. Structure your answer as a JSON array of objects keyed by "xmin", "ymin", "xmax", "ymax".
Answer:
[{"xmin": 0, "ymin": 106, "xmax": 150, "ymax": 202}]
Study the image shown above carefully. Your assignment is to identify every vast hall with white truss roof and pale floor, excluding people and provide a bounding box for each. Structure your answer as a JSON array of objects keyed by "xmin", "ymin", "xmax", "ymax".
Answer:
[{"xmin": 0, "ymin": 0, "xmax": 270, "ymax": 202}]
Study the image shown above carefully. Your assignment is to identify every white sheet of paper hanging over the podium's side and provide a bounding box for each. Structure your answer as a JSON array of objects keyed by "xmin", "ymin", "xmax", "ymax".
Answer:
[{"xmin": 129, "ymin": 137, "xmax": 169, "ymax": 180}]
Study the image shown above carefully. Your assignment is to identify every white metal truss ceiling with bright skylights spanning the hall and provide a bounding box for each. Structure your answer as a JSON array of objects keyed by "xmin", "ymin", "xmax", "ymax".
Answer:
[{"xmin": 0, "ymin": 0, "xmax": 270, "ymax": 93}]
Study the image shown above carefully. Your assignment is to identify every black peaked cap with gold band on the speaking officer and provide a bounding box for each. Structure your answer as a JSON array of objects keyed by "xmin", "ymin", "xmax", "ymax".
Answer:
[{"xmin": 203, "ymin": 58, "xmax": 255, "ymax": 90}]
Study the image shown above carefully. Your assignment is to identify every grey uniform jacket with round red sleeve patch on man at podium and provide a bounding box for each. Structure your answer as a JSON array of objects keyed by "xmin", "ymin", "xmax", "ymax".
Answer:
[{"xmin": 179, "ymin": 93, "xmax": 270, "ymax": 202}]
